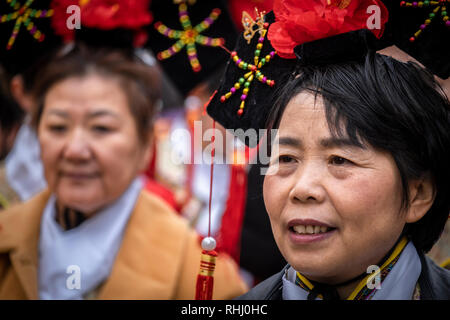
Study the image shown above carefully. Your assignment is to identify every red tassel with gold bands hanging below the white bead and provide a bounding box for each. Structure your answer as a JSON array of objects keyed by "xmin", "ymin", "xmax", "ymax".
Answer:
[{"xmin": 195, "ymin": 250, "xmax": 217, "ymax": 300}]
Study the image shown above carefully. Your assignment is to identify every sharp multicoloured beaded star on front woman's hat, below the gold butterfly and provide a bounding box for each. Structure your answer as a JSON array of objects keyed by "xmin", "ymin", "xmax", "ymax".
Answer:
[{"xmin": 220, "ymin": 23, "xmax": 276, "ymax": 116}]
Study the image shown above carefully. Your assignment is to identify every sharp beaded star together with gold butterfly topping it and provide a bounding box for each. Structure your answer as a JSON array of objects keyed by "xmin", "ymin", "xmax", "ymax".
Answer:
[{"xmin": 220, "ymin": 11, "xmax": 276, "ymax": 116}]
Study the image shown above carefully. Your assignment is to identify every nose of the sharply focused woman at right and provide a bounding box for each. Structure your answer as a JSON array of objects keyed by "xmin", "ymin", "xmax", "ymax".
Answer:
[{"xmin": 289, "ymin": 160, "xmax": 326, "ymax": 203}]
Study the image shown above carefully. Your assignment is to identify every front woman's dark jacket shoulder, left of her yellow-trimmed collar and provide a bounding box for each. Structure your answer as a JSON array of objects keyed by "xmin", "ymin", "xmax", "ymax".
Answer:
[{"xmin": 236, "ymin": 266, "xmax": 289, "ymax": 300}]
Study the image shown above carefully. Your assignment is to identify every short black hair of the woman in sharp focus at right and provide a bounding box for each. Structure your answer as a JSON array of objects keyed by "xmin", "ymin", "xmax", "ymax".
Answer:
[{"xmin": 267, "ymin": 53, "xmax": 450, "ymax": 252}]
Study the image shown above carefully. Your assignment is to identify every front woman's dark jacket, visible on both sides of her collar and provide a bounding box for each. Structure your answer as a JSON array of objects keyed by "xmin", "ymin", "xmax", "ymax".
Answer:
[{"xmin": 236, "ymin": 252, "xmax": 450, "ymax": 300}]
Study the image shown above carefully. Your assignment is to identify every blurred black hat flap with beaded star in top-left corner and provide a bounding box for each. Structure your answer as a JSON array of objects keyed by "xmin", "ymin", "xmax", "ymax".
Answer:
[{"xmin": 0, "ymin": 0, "xmax": 61, "ymax": 75}]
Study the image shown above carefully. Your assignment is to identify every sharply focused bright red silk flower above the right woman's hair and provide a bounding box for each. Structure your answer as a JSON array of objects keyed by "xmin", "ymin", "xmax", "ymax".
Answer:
[{"xmin": 267, "ymin": 0, "xmax": 388, "ymax": 59}]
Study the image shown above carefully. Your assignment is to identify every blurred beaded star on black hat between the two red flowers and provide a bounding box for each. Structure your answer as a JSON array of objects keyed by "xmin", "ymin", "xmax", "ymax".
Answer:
[{"xmin": 154, "ymin": 0, "xmax": 225, "ymax": 72}]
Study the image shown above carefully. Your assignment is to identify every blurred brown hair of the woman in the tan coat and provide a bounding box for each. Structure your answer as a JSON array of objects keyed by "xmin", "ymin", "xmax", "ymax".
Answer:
[{"xmin": 32, "ymin": 44, "xmax": 160, "ymax": 143}]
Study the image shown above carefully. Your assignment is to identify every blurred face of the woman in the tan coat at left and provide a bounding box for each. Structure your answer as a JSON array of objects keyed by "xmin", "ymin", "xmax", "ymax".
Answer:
[{"xmin": 38, "ymin": 75, "xmax": 150, "ymax": 215}]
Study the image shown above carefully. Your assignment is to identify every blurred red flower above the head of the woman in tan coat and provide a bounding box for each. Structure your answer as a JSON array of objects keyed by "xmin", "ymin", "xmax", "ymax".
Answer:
[{"xmin": 51, "ymin": 0, "xmax": 153, "ymax": 41}]
